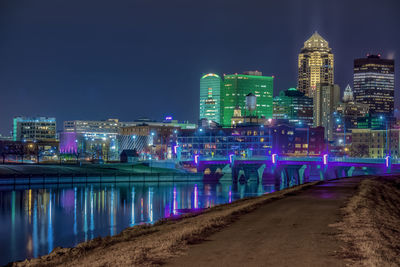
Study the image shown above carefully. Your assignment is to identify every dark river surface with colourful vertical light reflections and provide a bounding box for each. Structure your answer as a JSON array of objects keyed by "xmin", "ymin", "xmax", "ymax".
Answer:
[{"xmin": 0, "ymin": 182, "xmax": 274, "ymax": 265}]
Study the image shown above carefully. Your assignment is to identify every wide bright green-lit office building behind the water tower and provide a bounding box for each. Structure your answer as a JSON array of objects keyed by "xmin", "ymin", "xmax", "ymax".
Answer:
[{"xmin": 221, "ymin": 71, "xmax": 274, "ymax": 127}]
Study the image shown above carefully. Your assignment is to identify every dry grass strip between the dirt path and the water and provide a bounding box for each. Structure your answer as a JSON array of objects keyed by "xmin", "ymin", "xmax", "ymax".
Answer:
[{"xmin": 12, "ymin": 182, "xmax": 318, "ymax": 266}]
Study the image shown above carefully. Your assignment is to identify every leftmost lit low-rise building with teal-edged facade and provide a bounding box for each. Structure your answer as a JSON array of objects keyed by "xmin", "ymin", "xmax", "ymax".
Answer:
[{"xmin": 13, "ymin": 117, "xmax": 56, "ymax": 141}]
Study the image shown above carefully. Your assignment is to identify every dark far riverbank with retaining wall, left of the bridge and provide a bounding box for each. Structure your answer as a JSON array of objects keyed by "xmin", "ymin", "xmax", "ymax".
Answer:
[{"xmin": 0, "ymin": 163, "xmax": 185, "ymax": 178}]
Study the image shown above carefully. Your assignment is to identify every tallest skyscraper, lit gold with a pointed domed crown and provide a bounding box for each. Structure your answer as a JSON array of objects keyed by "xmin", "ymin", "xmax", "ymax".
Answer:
[{"xmin": 297, "ymin": 32, "xmax": 334, "ymax": 97}]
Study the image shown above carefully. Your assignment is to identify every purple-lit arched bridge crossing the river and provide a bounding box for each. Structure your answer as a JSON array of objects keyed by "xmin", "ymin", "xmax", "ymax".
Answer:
[{"xmin": 179, "ymin": 154, "xmax": 400, "ymax": 188}]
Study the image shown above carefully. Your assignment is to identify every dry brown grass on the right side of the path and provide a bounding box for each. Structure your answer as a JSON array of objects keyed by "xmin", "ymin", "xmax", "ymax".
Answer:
[{"xmin": 333, "ymin": 177, "xmax": 400, "ymax": 266}]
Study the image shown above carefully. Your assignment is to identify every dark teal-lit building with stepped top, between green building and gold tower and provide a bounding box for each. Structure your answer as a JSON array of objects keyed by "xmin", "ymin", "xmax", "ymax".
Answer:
[{"xmin": 273, "ymin": 88, "xmax": 313, "ymax": 126}]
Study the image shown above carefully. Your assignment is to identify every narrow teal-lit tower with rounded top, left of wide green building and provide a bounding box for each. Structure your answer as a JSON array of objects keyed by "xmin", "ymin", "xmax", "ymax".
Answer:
[{"xmin": 200, "ymin": 73, "xmax": 222, "ymax": 123}]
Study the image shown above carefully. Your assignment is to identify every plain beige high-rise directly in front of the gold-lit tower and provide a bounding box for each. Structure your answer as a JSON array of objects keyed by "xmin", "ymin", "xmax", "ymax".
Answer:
[{"xmin": 314, "ymin": 83, "xmax": 340, "ymax": 140}]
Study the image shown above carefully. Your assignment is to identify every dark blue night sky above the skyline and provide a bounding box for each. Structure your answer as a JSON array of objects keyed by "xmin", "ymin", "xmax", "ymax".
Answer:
[{"xmin": 0, "ymin": 0, "xmax": 400, "ymax": 135}]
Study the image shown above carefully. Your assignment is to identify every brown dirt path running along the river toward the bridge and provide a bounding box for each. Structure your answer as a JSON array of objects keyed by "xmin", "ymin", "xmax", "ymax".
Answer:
[{"xmin": 167, "ymin": 178, "xmax": 363, "ymax": 267}]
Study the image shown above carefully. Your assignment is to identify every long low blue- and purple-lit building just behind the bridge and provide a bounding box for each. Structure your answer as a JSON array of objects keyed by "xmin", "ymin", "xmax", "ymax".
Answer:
[{"xmin": 177, "ymin": 125, "xmax": 325, "ymax": 158}]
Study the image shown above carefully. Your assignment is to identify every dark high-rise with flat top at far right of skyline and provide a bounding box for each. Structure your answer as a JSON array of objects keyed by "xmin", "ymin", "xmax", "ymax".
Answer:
[{"xmin": 354, "ymin": 55, "xmax": 394, "ymax": 117}]
